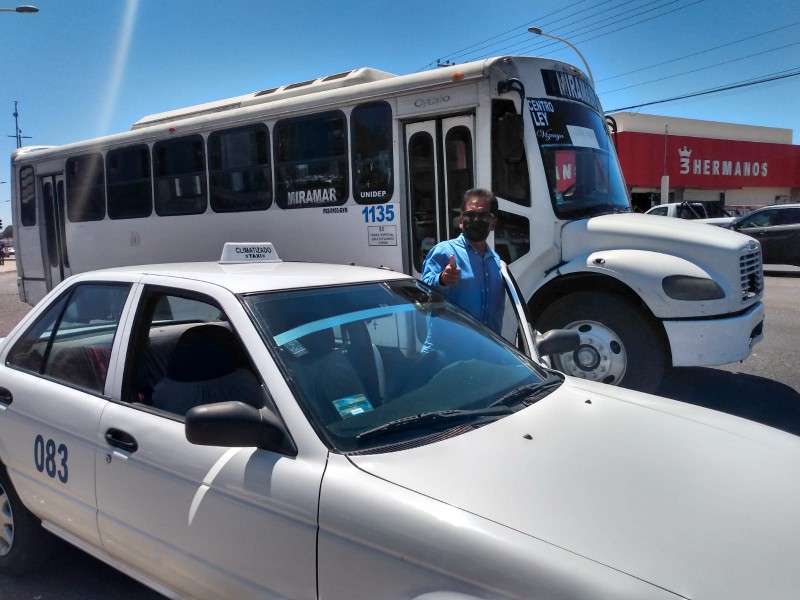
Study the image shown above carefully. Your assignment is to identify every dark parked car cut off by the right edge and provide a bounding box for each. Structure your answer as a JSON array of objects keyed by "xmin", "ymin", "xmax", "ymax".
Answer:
[{"xmin": 727, "ymin": 204, "xmax": 800, "ymax": 266}]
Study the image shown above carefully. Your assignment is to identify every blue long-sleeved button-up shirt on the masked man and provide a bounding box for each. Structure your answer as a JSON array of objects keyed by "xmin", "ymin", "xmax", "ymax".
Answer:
[{"xmin": 422, "ymin": 233, "xmax": 505, "ymax": 333}]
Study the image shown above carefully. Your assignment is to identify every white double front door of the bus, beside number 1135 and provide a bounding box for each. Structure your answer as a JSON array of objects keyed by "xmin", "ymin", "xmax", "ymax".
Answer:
[{"xmin": 405, "ymin": 115, "xmax": 475, "ymax": 276}]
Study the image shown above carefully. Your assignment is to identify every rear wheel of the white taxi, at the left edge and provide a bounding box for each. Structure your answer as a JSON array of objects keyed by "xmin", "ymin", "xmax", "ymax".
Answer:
[{"xmin": 0, "ymin": 465, "xmax": 55, "ymax": 575}]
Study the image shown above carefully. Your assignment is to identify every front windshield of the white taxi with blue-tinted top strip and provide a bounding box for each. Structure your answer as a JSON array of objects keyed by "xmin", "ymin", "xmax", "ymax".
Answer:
[{"xmin": 245, "ymin": 280, "xmax": 560, "ymax": 452}]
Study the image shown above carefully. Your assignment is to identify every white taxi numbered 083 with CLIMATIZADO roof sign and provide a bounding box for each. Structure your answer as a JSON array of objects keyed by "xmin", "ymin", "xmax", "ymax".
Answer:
[{"xmin": 0, "ymin": 244, "xmax": 800, "ymax": 600}]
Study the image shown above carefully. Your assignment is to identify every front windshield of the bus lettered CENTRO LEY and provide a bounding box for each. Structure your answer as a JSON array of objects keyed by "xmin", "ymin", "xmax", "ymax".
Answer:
[{"xmin": 528, "ymin": 98, "xmax": 630, "ymax": 219}]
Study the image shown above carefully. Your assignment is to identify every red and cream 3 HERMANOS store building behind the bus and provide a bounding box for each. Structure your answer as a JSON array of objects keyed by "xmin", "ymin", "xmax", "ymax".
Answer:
[{"xmin": 611, "ymin": 113, "xmax": 800, "ymax": 212}]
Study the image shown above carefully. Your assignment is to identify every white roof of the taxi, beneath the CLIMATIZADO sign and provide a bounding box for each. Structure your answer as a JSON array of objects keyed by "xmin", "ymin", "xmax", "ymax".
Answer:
[{"xmin": 76, "ymin": 262, "xmax": 410, "ymax": 294}]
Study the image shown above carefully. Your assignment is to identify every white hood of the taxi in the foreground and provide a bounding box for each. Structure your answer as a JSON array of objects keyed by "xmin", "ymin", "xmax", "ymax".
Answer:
[{"xmin": 350, "ymin": 379, "xmax": 800, "ymax": 599}]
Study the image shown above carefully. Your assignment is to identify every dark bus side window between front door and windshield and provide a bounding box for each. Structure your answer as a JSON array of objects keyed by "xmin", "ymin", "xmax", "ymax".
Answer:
[{"xmin": 492, "ymin": 100, "xmax": 531, "ymax": 206}]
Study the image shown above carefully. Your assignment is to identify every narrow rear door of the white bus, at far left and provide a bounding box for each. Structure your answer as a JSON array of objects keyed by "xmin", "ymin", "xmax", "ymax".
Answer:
[{"xmin": 40, "ymin": 173, "xmax": 71, "ymax": 289}]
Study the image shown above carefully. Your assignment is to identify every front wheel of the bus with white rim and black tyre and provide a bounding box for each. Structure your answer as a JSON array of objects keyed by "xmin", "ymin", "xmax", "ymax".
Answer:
[{"xmin": 536, "ymin": 292, "xmax": 666, "ymax": 392}]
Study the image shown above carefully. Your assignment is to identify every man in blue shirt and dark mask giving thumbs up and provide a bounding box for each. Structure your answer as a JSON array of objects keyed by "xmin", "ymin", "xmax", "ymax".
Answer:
[{"xmin": 422, "ymin": 188, "xmax": 505, "ymax": 346}]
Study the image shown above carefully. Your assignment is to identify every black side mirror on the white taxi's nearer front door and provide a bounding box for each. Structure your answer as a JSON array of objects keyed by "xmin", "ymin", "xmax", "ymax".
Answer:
[{"xmin": 185, "ymin": 401, "xmax": 297, "ymax": 456}]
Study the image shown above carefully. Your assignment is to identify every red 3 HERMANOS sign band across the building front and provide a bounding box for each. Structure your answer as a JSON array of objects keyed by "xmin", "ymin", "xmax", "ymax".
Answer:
[{"xmin": 616, "ymin": 131, "xmax": 800, "ymax": 190}]
